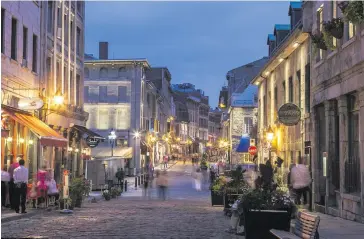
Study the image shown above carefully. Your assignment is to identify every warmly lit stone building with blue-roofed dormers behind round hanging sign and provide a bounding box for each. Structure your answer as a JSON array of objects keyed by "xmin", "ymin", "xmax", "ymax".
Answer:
[{"xmin": 252, "ymin": 2, "xmax": 310, "ymax": 174}]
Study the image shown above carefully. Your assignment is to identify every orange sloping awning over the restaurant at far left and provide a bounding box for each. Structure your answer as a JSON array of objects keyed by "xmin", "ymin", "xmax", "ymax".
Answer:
[{"xmin": 1, "ymin": 105, "xmax": 67, "ymax": 147}]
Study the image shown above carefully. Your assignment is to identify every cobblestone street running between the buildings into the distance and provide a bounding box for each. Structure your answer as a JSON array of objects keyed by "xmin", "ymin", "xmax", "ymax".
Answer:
[{"xmin": 1, "ymin": 163, "xmax": 241, "ymax": 239}]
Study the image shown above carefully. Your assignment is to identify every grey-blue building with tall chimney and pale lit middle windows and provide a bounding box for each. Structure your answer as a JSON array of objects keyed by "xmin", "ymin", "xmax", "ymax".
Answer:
[{"xmin": 84, "ymin": 43, "xmax": 150, "ymax": 175}]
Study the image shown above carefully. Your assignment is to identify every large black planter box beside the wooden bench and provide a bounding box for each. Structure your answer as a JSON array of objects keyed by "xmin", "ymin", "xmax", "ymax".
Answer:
[{"xmin": 242, "ymin": 210, "xmax": 291, "ymax": 239}]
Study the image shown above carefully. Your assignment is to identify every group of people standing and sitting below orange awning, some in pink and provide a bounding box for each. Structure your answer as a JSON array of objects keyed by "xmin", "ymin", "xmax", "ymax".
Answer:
[{"xmin": 1, "ymin": 157, "xmax": 59, "ymax": 213}]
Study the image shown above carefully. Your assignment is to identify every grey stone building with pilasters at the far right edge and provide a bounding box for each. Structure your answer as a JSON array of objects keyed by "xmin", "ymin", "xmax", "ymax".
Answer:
[{"xmin": 303, "ymin": 1, "xmax": 364, "ymax": 222}]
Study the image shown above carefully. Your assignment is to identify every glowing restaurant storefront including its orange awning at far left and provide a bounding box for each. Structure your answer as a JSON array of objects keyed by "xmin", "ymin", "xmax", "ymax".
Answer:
[{"xmin": 1, "ymin": 105, "xmax": 67, "ymax": 178}]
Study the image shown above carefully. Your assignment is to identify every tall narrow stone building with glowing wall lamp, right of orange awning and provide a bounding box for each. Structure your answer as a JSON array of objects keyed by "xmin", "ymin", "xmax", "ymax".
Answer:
[{"xmin": 39, "ymin": 1, "xmax": 91, "ymax": 177}]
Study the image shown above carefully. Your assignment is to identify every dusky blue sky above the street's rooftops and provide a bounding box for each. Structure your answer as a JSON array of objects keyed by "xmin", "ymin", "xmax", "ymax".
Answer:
[{"xmin": 85, "ymin": 2, "xmax": 289, "ymax": 107}]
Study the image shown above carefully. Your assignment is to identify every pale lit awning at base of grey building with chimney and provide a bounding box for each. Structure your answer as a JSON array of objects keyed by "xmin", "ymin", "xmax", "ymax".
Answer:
[{"xmin": 91, "ymin": 146, "xmax": 133, "ymax": 159}]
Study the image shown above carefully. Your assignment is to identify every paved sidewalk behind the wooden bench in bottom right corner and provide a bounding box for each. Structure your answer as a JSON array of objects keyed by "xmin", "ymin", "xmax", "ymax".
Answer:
[{"xmin": 291, "ymin": 212, "xmax": 364, "ymax": 239}]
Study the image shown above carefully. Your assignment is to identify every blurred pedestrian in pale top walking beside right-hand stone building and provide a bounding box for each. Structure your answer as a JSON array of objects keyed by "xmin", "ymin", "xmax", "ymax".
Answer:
[{"xmin": 290, "ymin": 164, "xmax": 312, "ymax": 205}]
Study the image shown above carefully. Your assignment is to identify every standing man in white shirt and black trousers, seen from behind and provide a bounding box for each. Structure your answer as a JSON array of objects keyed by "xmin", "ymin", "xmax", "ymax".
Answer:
[{"xmin": 14, "ymin": 159, "xmax": 29, "ymax": 213}]
